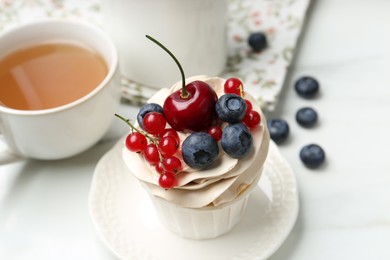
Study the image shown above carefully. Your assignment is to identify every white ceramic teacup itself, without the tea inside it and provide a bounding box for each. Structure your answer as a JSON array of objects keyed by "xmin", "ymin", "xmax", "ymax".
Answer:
[{"xmin": 0, "ymin": 20, "xmax": 120, "ymax": 164}]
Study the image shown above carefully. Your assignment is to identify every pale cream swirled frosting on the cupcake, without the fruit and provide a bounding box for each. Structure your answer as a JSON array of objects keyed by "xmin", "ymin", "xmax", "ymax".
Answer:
[{"xmin": 123, "ymin": 76, "xmax": 270, "ymax": 208}]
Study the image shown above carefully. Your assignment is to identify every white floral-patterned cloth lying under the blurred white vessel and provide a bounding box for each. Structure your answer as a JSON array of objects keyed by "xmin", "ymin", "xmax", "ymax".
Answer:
[{"xmin": 0, "ymin": 0, "xmax": 310, "ymax": 111}]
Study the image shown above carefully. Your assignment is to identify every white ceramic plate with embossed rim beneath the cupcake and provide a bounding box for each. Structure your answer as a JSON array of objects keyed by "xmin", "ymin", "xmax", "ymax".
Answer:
[{"xmin": 89, "ymin": 141, "xmax": 299, "ymax": 260}]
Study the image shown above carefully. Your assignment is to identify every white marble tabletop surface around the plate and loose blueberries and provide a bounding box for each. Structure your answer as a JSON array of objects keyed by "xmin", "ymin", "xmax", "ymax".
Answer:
[{"xmin": 0, "ymin": 0, "xmax": 390, "ymax": 260}]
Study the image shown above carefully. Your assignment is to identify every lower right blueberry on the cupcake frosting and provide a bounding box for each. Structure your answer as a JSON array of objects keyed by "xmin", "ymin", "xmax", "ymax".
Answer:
[{"xmin": 221, "ymin": 123, "xmax": 253, "ymax": 158}]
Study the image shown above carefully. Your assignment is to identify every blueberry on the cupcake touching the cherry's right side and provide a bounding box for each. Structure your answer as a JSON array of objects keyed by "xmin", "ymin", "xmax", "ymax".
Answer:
[{"xmin": 215, "ymin": 94, "xmax": 246, "ymax": 124}]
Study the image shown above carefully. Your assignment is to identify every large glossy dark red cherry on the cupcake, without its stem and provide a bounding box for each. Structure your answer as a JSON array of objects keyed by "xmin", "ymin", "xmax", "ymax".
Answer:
[{"xmin": 163, "ymin": 81, "xmax": 218, "ymax": 131}]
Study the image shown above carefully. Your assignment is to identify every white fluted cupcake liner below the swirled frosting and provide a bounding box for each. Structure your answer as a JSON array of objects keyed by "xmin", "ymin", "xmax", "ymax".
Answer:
[{"xmin": 144, "ymin": 173, "xmax": 261, "ymax": 240}]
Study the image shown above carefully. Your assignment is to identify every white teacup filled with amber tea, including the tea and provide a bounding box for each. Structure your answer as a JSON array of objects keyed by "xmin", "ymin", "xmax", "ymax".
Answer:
[{"xmin": 0, "ymin": 19, "xmax": 120, "ymax": 162}]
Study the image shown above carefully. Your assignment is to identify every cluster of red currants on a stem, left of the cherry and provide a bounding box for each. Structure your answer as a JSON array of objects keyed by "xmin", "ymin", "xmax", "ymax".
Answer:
[{"xmin": 116, "ymin": 112, "xmax": 182, "ymax": 189}]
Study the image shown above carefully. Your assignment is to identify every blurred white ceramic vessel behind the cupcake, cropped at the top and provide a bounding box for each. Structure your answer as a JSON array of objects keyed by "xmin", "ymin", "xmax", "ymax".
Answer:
[{"xmin": 101, "ymin": 0, "xmax": 228, "ymax": 88}]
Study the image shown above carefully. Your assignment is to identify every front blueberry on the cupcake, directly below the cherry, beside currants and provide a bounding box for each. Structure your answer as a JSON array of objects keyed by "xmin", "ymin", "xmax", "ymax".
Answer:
[{"xmin": 182, "ymin": 132, "xmax": 219, "ymax": 169}]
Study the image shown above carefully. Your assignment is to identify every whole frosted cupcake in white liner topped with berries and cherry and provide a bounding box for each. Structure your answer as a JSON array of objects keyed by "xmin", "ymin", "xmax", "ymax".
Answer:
[{"xmin": 122, "ymin": 76, "xmax": 270, "ymax": 239}]
